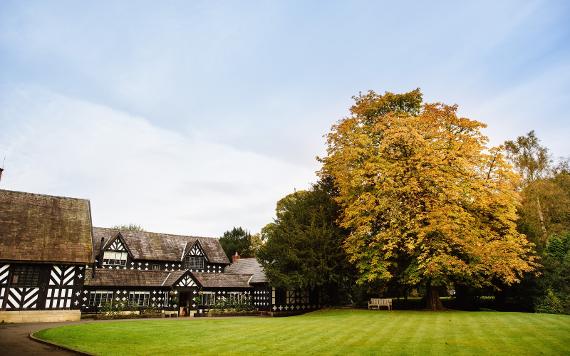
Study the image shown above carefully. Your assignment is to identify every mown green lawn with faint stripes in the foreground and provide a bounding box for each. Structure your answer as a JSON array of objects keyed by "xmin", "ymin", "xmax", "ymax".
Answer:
[{"xmin": 35, "ymin": 310, "xmax": 570, "ymax": 356}]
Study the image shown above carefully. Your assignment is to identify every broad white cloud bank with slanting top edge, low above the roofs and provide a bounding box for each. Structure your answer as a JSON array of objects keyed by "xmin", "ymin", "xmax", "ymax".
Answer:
[{"xmin": 0, "ymin": 87, "xmax": 317, "ymax": 236}]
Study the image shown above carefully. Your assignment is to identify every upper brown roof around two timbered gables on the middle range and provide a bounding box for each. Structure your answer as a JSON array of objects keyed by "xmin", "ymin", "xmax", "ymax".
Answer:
[{"xmin": 93, "ymin": 227, "xmax": 230, "ymax": 264}]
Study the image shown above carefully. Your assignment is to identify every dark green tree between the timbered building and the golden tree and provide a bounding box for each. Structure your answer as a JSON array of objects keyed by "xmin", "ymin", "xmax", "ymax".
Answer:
[{"xmin": 258, "ymin": 184, "xmax": 352, "ymax": 303}]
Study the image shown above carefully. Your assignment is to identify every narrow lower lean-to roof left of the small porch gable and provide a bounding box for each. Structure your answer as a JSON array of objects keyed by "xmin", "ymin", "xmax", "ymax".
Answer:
[{"xmin": 85, "ymin": 268, "xmax": 186, "ymax": 287}]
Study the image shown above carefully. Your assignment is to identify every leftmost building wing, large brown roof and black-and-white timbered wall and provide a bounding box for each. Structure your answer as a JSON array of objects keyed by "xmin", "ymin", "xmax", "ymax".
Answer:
[{"xmin": 0, "ymin": 190, "xmax": 92, "ymax": 322}]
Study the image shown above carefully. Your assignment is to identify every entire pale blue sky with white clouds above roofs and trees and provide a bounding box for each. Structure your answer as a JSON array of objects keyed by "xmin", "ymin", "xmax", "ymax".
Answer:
[{"xmin": 0, "ymin": 0, "xmax": 570, "ymax": 236}]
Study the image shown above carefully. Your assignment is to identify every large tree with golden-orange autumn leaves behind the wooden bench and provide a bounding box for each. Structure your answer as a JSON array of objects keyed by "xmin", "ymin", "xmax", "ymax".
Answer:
[{"xmin": 320, "ymin": 89, "xmax": 535, "ymax": 310}]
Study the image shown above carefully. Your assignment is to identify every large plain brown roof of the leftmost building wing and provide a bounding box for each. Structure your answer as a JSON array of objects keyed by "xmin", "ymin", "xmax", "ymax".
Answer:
[{"xmin": 0, "ymin": 189, "xmax": 92, "ymax": 263}]
